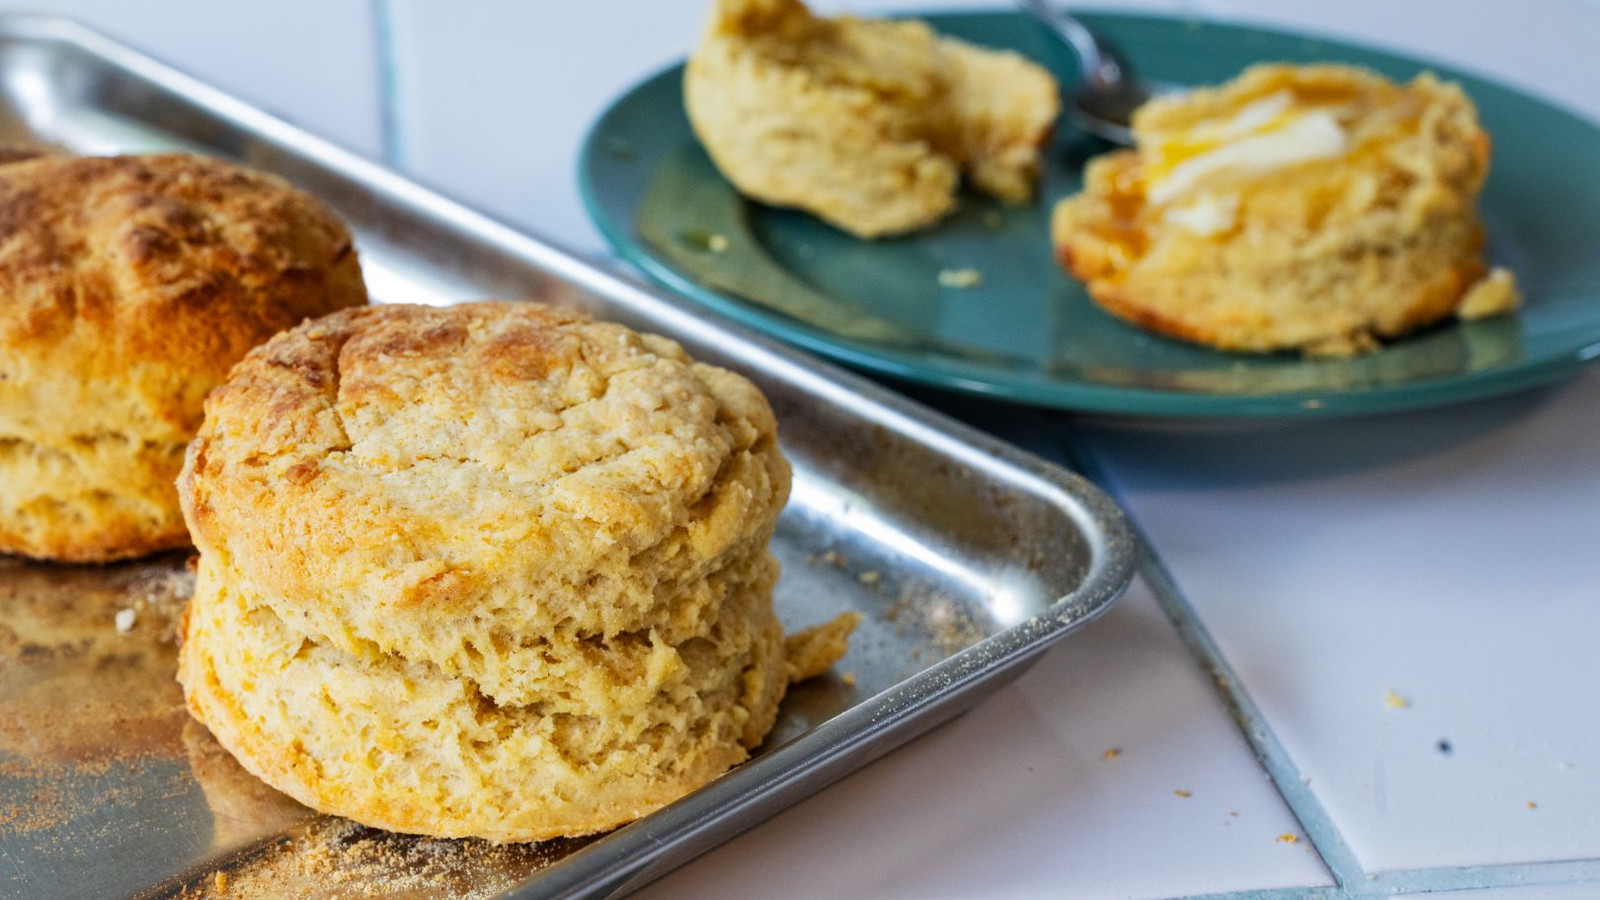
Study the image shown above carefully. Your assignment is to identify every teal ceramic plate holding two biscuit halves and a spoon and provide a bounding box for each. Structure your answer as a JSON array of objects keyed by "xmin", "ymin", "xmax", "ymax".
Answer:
[{"xmin": 579, "ymin": 13, "xmax": 1600, "ymax": 418}]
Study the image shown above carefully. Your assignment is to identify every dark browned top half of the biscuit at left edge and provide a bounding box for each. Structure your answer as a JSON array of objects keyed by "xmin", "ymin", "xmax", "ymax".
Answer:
[{"xmin": 0, "ymin": 154, "xmax": 366, "ymax": 439}]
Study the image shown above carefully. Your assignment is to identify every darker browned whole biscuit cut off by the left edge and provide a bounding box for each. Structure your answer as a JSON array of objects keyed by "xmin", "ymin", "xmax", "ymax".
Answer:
[{"xmin": 0, "ymin": 155, "xmax": 366, "ymax": 562}]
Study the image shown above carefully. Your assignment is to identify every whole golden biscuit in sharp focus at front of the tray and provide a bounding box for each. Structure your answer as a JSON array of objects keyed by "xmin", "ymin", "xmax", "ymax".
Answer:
[{"xmin": 179, "ymin": 304, "xmax": 857, "ymax": 841}]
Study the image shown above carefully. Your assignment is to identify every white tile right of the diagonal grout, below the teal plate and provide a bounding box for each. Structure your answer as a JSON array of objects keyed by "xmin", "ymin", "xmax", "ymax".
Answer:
[{"xmin": 1094, "ymin": 372, "xmax": 1600, "ymax": 870}]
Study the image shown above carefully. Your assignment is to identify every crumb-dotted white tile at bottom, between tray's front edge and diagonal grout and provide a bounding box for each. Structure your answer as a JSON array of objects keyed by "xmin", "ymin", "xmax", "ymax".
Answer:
[{"xmin": 638, "ymin": 583, "xmax": 1328, "ymax": 900}]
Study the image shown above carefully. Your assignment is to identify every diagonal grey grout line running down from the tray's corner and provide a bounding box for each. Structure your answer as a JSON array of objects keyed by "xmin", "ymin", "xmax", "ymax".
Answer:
[{"xmin": 1053, "ymin": 428, "xmax": 1371, "ymax": 892}]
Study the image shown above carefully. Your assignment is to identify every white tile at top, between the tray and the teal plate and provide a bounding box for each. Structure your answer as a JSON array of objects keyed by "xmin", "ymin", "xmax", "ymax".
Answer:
[{"xmin": 377, "ymin": 0, "xmax": 1182, "ymax": 253}]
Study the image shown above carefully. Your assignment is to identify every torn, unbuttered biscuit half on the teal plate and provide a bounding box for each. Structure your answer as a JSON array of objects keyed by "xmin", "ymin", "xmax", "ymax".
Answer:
[{"xmin": 685, "ymin": 0, "xmax": 1059, "ymax": 237}]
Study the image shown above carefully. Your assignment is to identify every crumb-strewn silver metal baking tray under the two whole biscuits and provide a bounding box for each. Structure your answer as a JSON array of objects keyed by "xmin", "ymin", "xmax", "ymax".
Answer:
[{"xmin": 0, "ymin": 18, "xmax": 1131, "ymax": 897}]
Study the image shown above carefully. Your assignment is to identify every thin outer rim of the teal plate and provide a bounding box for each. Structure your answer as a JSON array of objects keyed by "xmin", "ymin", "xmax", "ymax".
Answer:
[{"xmin": 578, "ymin": 8, "xmax": 1600, "ymax": 420}]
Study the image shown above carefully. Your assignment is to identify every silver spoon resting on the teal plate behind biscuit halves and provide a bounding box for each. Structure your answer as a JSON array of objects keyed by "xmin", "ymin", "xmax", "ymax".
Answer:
[{"xmin": 1018, "ymin": 0, "xmax": 1181, "ymax": 146}]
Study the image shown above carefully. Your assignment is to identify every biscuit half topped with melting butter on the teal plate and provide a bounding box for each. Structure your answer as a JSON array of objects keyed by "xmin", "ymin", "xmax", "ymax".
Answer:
[{"xmin": 1051, "ymin": 64, "xmax": 1517, "ymax": 357}]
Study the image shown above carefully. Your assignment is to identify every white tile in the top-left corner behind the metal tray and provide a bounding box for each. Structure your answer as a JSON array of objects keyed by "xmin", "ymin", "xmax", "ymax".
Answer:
[{"xmin": 6, "ymin": 0, "xmax": 382, "ymax": 159}]
